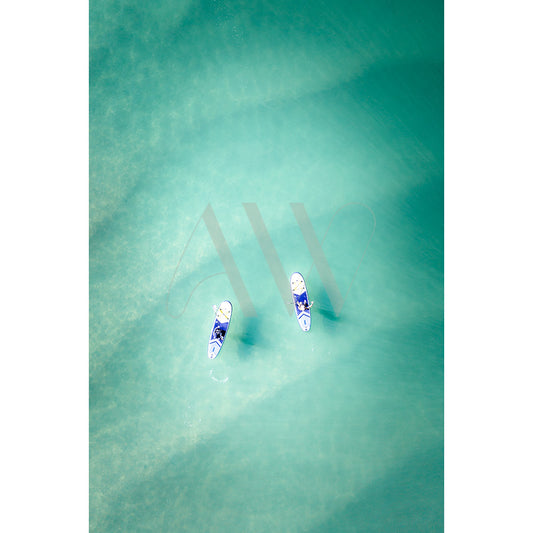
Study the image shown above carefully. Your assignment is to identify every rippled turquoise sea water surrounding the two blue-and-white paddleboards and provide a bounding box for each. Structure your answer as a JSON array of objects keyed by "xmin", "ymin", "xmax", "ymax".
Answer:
[{"xmin": 89, "ymin": 0, "xmax": 444, "ymax": 532}]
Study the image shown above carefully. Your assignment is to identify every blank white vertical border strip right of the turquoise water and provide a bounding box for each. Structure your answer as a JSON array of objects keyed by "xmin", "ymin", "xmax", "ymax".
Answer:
[{"xmin": 445, "ymin": 0, "xmax": 533, "ymax": 532}]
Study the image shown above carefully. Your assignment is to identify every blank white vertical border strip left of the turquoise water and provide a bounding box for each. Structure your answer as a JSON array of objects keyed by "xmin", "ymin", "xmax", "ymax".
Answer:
[{"xmin": 0, "ymin": 1, "xmax": 89, "ymax": 532}]
